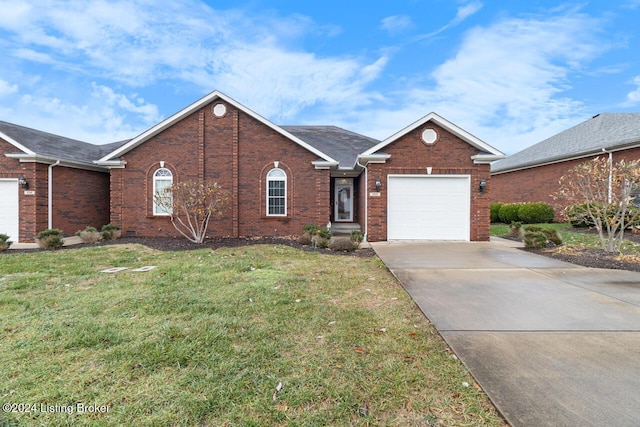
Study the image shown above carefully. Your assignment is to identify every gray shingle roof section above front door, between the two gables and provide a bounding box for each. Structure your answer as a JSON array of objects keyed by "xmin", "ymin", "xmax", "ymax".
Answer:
[{"xmin": 280, "ymin": 126, "xmax": 380, "ymax": 169}]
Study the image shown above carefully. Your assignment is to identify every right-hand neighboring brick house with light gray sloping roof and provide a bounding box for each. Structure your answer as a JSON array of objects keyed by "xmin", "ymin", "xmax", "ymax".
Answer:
[{"xmin": 491, "ymin": 113, "xmax": 640, "ymax": 212}]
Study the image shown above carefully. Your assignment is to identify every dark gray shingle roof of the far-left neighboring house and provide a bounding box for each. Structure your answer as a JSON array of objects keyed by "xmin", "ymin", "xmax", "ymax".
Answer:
[{"xmin": 0, "ymin": 121, "xmax": 126, "ymax": 165}]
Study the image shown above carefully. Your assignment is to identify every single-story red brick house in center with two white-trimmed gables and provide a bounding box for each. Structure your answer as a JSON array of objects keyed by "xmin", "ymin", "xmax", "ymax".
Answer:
[{"xmin": 0, "ymin": 91, "xmax": 504, "ymax": 241}]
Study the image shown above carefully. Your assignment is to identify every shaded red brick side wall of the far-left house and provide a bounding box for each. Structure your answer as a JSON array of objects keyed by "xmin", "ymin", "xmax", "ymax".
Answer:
[{"xmin": 52, "ymin": 166, "xmax": 110, "ymax": 236}]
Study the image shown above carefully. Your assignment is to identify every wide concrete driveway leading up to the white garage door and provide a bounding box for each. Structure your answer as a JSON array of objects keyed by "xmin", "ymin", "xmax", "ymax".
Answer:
[{"xmin": 372, "ymin": 239, "xmax": 640, "ymax": 427}]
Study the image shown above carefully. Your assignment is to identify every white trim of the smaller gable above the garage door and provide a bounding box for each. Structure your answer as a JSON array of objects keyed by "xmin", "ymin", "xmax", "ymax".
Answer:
[{"xmin": 361, "ymin": 112, "xmax": 505, "ymax": 163}]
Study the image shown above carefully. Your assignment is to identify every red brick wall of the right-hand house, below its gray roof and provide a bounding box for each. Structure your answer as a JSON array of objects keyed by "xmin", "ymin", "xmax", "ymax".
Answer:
[{"xmin": 491, "ymin": 148, "xmax": 640, "ymax": 219}]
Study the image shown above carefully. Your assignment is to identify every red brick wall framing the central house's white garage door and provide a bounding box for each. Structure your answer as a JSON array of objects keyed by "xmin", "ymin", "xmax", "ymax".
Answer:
[{"xmin": 367, "ymin": 123, "xmax": 491, "ymax": 242}]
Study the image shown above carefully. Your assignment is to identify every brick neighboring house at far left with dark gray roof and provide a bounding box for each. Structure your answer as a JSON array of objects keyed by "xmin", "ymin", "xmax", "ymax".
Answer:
[{"xmin": 0, "ymin": 121, "xmax": 121, "ymax": 242}]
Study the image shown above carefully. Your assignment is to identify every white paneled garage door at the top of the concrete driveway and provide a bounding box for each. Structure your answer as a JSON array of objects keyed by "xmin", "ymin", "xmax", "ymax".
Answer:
[{"xmin": 387, "ymin": 175, "xmax": 471, "ymax": 241}]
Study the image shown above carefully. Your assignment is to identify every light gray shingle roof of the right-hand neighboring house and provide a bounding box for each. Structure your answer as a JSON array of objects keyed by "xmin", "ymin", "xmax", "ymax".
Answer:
[{"xmin": 491, "ymin": 113, "xmax": 640, "ymax": 173}]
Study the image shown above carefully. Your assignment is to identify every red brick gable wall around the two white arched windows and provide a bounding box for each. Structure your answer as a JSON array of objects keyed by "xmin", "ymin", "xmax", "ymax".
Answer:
[{"xmin": 111, "ymin": 100, "xmax": 330, "ymax": 241}]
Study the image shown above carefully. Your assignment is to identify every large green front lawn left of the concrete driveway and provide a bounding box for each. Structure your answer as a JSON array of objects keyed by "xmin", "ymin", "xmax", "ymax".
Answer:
[{"xmin": 0, "ymin": 245, "xmax": 504, "ymax": 426}]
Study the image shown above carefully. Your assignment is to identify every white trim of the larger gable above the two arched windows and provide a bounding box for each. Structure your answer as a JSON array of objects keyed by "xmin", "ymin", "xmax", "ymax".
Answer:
[{"xmin": 96, "ymin": 90, "xmax": 337, "ymax": 165}]
